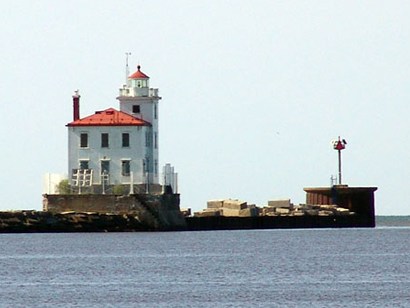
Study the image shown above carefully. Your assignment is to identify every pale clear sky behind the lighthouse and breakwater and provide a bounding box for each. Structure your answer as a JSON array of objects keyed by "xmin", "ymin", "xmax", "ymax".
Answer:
[{"xmin": 0, "ymin": 0, "xmax": 410, "ymax": 215}]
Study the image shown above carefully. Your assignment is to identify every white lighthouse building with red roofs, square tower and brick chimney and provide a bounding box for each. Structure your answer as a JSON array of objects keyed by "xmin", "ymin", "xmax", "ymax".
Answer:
[{"xmin": 67, "ymin": 66, "xmax": 176, "ymax": 193}]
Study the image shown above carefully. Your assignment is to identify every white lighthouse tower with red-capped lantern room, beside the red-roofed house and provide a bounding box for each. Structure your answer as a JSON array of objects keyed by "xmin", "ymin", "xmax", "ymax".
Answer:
[{"xmin": 117, "ymin": 65, "xmax": 161, "ymax": 183}]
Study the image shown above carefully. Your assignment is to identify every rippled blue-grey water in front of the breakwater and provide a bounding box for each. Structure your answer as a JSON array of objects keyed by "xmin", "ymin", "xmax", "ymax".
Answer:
[{"xmin": 0, "ymin": 227, "xmax": 410, "ymax": 307}]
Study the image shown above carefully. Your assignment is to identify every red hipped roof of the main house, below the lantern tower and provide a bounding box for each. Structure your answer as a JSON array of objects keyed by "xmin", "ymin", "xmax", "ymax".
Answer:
[{"xmin": 67, "ymin": 108, "xmax": 151, "ymax": 126}]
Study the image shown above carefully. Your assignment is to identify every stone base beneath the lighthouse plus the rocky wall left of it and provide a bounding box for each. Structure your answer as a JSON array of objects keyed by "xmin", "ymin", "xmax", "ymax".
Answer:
[{"xmin": 0, "ymin": 194, "xmax": 186, "ymax": 233}]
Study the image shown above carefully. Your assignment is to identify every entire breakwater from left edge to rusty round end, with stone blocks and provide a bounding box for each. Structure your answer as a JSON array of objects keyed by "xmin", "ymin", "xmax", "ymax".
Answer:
[{"xmin": 0, "ymin": 186, "xmax": 377, "ymax": 232}]
